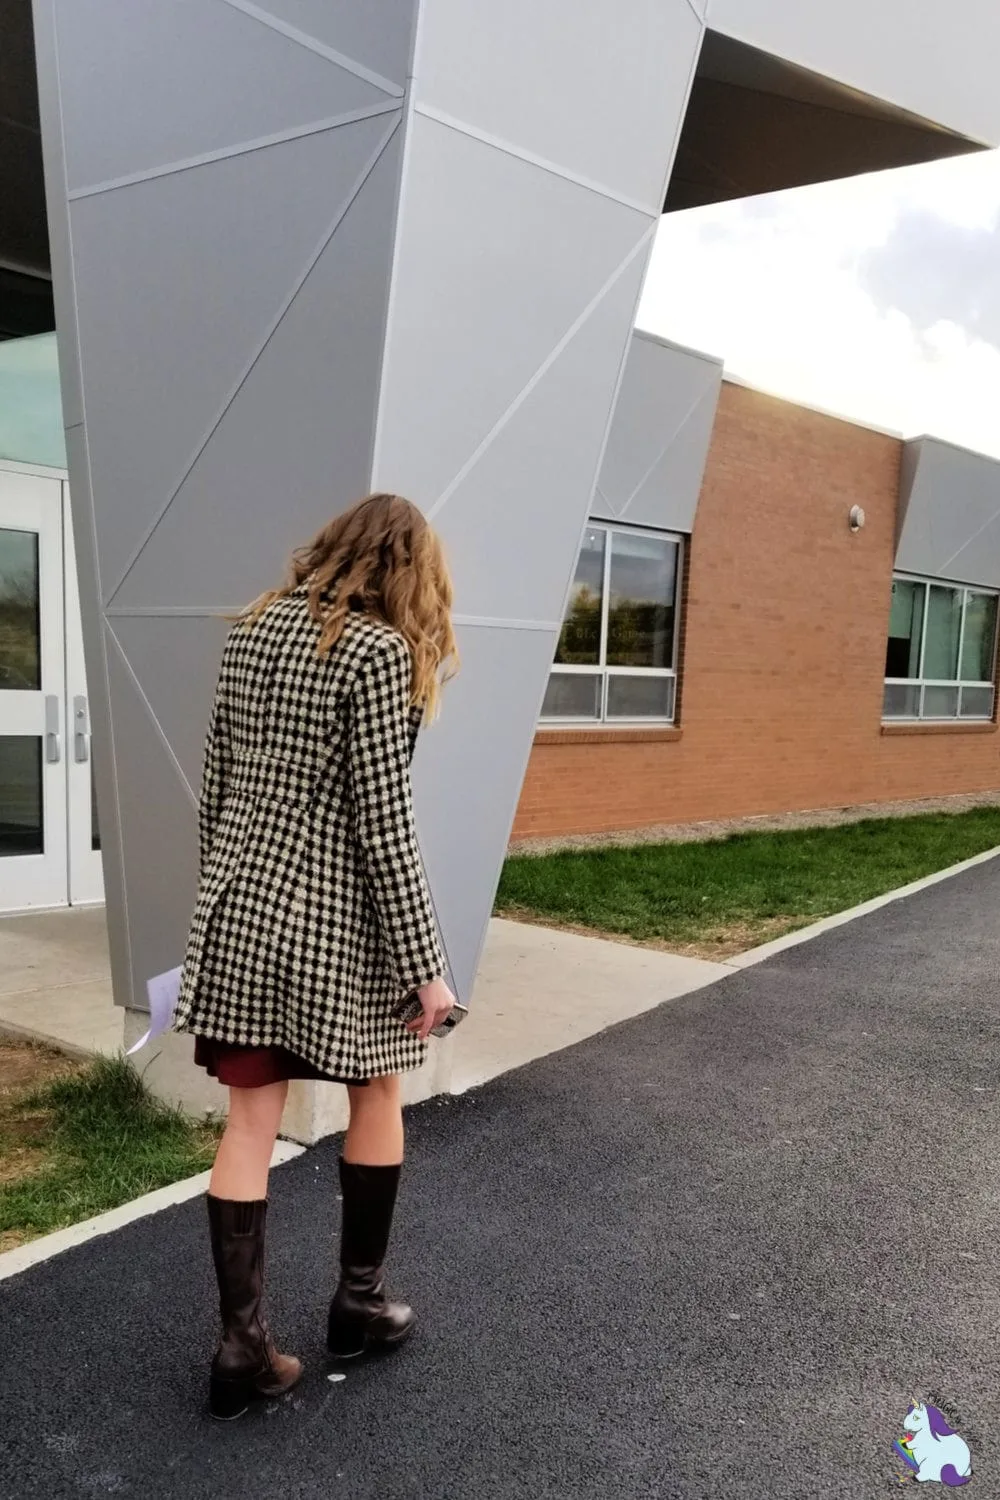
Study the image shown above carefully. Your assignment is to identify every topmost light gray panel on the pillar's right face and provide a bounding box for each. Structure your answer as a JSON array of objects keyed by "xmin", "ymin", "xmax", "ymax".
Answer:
[{"xmin": 417, "ymin": 0, "xmax": 702, "ymax": 212}]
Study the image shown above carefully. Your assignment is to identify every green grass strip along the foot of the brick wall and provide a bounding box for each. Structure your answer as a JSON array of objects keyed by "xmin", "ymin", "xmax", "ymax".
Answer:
[{"xmin": 496, "ymin": 807, "xmax": 1000, "ymax": 957}]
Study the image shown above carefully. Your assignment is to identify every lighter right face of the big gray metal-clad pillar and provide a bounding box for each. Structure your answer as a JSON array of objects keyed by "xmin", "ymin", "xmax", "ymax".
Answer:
[{"xmin": 375, "ymin": 0, "xmax": 702, "ymax": 993}]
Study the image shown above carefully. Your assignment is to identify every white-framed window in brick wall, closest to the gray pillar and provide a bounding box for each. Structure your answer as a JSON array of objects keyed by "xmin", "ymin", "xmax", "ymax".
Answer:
[{"xmin": 541, "ymin": 525, "xmax": 681, "ymax": 723}]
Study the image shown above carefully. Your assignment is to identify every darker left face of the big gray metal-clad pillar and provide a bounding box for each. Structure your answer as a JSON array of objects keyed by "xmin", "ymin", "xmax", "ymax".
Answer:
[{"xmin": 36, "ymin": 0, "xmax": 415, "ymax": 1005}]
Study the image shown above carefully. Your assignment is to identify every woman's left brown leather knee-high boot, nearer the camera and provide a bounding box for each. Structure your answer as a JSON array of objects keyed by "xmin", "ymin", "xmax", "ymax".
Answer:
[{"xmin": 205, "ymin": 1194, "xmax": 303, "ymax": 1421}]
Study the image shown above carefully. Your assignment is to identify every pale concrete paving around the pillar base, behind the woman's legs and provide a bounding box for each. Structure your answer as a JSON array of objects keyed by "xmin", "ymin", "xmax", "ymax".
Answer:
[{"xmin": 0, "ymin": 909, "xmax": 727, "ymax": 1143}]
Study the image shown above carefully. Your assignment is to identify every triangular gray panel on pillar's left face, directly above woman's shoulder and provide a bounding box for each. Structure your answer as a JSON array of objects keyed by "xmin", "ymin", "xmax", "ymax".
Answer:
[{"xmin": 115, "ymin": 132, "xmax": 410, "ymax": 609}]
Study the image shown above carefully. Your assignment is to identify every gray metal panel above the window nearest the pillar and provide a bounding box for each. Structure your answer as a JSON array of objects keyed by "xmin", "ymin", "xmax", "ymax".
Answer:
[{"xmin": 592, "ymin": 332, "xmax": 723, "ymax": 533}]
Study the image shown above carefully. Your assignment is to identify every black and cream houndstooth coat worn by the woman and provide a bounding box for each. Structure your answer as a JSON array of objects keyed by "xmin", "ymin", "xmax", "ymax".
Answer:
[{"xmin": 174, "ymin": 585, "xmax": 445, "ymax": 1082}]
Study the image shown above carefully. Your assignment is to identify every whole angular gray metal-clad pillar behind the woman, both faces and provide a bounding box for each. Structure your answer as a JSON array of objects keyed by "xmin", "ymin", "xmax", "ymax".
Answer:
[{"xmin": 36, "ymin": 0, "xmax": 702, "ymax": 1005}]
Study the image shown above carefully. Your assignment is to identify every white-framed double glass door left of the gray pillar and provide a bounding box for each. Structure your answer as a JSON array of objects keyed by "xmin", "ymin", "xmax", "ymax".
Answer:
[{"xmin": 0, "ymin": 465, "xmax": 103, "ymax": 912}]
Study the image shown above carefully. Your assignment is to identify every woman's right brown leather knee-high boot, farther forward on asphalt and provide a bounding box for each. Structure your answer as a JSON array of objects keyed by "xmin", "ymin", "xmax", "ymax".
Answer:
[{"xmin": 327, "ymin": 1158, "xmax": 417, "ymax": 1359}]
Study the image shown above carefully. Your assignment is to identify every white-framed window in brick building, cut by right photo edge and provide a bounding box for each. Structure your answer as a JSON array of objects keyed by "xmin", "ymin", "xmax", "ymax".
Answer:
[{"xmin": 882, "ymin": 578, "xmax": 997, "ymax": 720}]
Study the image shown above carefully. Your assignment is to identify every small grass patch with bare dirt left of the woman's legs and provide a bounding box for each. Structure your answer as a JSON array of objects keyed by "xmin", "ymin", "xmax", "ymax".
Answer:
[{"xmin": 0, "ymin": 1058, "xmax": 219, "ymax": 1248}]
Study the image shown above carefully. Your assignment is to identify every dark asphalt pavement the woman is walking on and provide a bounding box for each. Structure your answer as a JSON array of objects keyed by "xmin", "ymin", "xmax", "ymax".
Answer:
[{"xmin": 0, "ymin": 861, "xmax": 1000, "ymax": 1500}]
